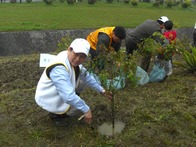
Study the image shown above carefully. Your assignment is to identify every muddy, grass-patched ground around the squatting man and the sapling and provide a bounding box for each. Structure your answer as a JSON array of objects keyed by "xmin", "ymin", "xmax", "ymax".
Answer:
[{"xmin": 0, "ymin": 54, "xmax": 196, "ymax": 146}]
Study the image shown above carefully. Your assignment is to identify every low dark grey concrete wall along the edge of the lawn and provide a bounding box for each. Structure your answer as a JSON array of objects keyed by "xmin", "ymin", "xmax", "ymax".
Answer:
[{"xmin": 0, "ymin": 28, "xmax": 194, "ymax": 56}]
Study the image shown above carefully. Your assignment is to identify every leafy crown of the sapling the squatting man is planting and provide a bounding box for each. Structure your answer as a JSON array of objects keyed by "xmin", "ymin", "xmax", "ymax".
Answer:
[{"xmin": 85, "ymin": 46, "xmax": 137, "ymax": 90}]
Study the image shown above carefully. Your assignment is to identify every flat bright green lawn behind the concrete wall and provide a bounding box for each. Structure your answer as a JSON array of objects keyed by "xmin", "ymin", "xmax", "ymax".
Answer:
[{"xmin": 0, "ymin": 1, "xmax": 196, "ymax": 31}]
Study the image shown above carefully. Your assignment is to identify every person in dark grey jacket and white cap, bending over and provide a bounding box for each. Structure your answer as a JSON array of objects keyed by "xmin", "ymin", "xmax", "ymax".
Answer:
[{"xmin": 125, "ymin": 16, "xmax": 169, "ymax": 71}]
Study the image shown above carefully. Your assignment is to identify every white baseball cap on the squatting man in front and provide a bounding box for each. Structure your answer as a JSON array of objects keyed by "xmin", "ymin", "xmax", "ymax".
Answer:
[{"xmin": 69, "ymin": 38, "xmax": 90, "ymax": 56}]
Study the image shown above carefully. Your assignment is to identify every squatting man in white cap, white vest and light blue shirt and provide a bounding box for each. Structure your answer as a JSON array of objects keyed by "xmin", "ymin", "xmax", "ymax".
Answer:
[{"xmin": 35, "ymin": 38, "xmax": 108, "ymax": 123}]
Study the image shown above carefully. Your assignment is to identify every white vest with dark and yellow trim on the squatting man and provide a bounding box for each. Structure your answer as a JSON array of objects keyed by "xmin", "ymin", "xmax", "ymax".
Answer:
[{"xmin": 35, "ymin": 51, "xmax": 81, "ymax": 114}]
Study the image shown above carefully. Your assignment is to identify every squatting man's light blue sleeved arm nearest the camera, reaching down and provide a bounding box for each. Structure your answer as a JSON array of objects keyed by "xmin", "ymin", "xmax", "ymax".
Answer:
[{"xmin": 50, "ymin": 65, "xmax": 90, "ymax": 113}]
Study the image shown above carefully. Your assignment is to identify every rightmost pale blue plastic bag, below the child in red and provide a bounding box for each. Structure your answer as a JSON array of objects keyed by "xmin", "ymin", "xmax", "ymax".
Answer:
[{"xmin": 149, "ymin": 63, "xmax": 166, "ymax": 82}]
